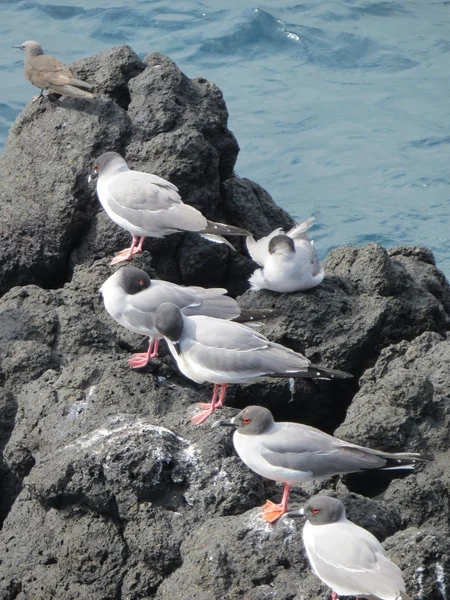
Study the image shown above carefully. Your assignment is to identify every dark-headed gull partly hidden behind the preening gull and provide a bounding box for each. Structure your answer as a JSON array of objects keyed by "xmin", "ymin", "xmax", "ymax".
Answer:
[{"xmin": 100, "ymin": 266, "xmax": 276, "ymax": 369}]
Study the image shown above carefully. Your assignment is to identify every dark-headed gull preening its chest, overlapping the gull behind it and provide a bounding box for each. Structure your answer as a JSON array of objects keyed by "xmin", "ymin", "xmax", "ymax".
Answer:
[{"xmin": 155, "ymin": 303, "xmax": 352, "ymax": 425}]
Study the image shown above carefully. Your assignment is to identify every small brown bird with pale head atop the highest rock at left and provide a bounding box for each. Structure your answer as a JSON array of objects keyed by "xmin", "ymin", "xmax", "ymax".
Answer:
[{"xmin": 13, "ymin": 40, "xmax": 95, "ymax": 102}]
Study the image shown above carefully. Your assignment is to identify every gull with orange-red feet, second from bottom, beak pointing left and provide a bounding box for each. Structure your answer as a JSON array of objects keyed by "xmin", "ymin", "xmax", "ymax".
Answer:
[{"xmin": 213, "ymin": 406, "xmax": 430, "ymax": 523}]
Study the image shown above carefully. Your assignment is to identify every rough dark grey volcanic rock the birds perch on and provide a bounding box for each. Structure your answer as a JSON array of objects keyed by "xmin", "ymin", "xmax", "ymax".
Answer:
[{"xmin": 0, "ymin": 47, "xmax": 450, "ymax": 600}]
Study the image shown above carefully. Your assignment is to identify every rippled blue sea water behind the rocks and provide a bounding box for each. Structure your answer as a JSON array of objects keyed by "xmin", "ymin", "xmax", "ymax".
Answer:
[{"xmin": 0, "ymin": 0, "xmax": 450, "ymax": 276}]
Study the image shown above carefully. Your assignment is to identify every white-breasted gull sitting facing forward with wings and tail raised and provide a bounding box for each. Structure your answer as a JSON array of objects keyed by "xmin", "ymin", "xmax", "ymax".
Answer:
[{"xmin": 246, "ymin": 217, "xmax": 325, "ymax": 292}]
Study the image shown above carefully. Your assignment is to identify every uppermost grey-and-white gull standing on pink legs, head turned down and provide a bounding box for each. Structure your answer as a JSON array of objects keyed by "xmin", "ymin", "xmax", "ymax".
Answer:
[{"xmin": 89, "ymin": 152, "xmax": 250, "ymax": 265}]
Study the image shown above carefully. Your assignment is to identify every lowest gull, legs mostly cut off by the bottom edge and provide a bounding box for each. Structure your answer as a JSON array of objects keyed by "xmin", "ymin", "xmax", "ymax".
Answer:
[{"xmin": 285, "ymin": 496, "xmax": 411, "ymax": 600}]
